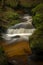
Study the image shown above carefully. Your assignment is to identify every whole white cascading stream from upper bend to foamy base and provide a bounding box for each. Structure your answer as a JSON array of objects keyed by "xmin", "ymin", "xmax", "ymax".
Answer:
[{"xmin": 2, "ymin": 14, "xmax": 35, "ymax": 43}]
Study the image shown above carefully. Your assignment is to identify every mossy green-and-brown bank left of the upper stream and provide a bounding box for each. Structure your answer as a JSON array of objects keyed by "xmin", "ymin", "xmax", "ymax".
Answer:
[{"xmin": 1, "ymin": 10, "xmax": 20, "ymax": 28}]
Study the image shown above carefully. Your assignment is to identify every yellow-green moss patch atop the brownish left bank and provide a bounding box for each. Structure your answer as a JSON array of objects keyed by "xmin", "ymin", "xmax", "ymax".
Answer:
[{"xmin": 3, "ymin": 11, "xmax": 19, "ymax": 19}]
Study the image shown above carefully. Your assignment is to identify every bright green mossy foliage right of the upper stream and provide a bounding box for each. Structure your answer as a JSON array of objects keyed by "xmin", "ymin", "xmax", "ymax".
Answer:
[{"xmin": 32, "ymin": 3, "xmax": 43, "ymax": 28}]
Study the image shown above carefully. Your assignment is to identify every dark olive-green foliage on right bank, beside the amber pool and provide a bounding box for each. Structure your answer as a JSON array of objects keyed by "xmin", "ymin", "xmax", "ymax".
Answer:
[{"xmin": 29, "ymin": 24, "xmax": 43, "ymax": 50}]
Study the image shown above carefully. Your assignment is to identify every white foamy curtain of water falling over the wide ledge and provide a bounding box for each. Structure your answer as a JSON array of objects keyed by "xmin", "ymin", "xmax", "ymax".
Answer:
[{"xmin": 8, "ymin": 28, "xmax": 35, "ymax": 35}]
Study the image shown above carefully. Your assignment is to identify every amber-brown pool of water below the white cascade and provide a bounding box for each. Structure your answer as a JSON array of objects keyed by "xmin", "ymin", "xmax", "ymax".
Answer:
[{"xmin": 0, "ymin": 41, "xmax": 43, "ymax": 65}]
